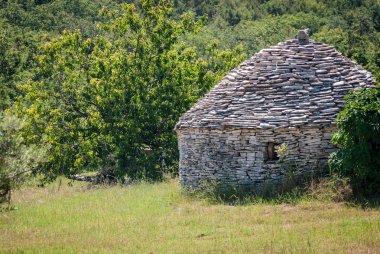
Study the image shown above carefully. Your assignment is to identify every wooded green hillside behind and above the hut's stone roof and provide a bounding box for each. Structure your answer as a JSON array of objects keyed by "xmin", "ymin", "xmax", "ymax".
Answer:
[{"xmin": 175, "ymin": 0, "xmax": 380, "ymax": 78}]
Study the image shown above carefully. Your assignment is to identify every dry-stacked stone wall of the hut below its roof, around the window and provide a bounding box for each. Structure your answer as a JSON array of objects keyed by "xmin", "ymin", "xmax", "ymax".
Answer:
[{"xmin": 178, "ymin": 127, "xmax": 336, "ymax": 188}]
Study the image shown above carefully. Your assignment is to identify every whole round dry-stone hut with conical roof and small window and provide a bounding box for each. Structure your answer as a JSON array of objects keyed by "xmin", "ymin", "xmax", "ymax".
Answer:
[{"xmin": 175, "ymin": 30, "xmax": 375, "ymax": 189}]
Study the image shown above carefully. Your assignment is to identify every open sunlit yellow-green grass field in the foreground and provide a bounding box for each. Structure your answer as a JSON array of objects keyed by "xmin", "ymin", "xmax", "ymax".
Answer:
[{"xmin": 0, "ymin": 181, "xmax": 380, "ymax": 253}]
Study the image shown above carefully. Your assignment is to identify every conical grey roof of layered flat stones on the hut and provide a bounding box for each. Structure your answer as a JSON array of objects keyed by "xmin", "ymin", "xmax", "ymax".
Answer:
[{"xmin": 176, "ymin": 36, "xmax": 374, "ymax": 130}]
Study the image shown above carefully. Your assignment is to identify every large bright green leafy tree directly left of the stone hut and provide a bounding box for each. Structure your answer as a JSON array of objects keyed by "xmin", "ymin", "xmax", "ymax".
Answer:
[{"xmin": 18, "ymin": 0, "xmax": 242, "ymax": 180}]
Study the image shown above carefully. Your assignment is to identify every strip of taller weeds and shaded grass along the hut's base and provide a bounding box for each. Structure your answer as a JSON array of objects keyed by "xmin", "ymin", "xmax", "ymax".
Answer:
[{"xmin": 183, "ymin": 175, "xmax": 380, "ymax": 209}]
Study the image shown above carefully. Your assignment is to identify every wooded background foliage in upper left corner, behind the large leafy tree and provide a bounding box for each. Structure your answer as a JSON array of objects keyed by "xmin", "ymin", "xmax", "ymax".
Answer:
[{"xmin": 0, "ymin": 0, "xmax": 121, "ymax": 111}]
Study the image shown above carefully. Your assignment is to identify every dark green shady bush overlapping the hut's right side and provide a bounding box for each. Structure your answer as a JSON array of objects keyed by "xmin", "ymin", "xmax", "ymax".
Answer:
[{"xmin": 330, "ymin": 87, "xmax": 380, "ymax": 195}]
